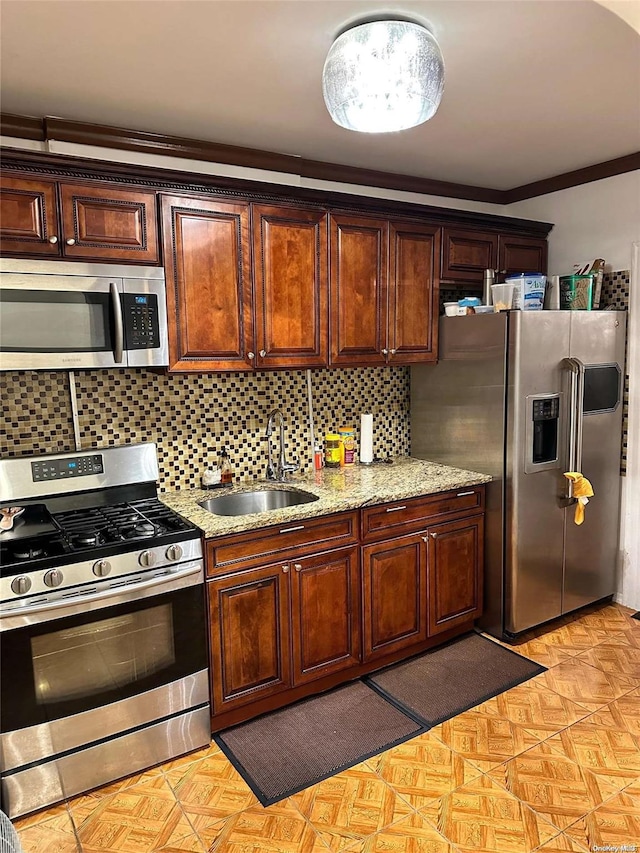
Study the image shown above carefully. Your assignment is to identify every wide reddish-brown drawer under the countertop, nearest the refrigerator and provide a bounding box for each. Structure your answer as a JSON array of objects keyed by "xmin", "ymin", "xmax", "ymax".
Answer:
[{"xmin": 362, "ymin": 486, "xmax": 484, "ymax": 542}]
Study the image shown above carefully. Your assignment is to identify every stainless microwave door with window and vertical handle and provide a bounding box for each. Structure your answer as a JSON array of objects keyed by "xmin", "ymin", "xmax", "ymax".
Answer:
[{"xmin": 0, "ymin": 273, "xmax": 126, "ymax": 370}]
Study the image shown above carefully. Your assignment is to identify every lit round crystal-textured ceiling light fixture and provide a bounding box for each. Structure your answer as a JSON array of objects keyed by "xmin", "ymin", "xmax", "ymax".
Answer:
[{"xmin": 322, "ymin": 21, "xmax": 444, "ymax": 133}]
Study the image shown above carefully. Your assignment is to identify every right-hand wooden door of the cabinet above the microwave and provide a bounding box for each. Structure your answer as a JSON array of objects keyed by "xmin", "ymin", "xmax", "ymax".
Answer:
[{"xmin": 60, "ymin": 183, "xmax": 159, "ymax": 264}]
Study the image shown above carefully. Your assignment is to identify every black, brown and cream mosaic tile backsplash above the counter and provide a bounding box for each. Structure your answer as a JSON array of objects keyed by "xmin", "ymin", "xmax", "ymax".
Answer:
[{"xmin": 0, "ymin": 367, "xmax": 410, "ymax": 489}]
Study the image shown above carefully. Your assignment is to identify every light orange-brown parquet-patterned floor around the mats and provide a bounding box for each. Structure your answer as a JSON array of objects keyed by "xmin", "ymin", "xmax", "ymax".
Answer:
[{"xmin": 16, "ymin": 604, "xmax": 640, "ymax": 853}]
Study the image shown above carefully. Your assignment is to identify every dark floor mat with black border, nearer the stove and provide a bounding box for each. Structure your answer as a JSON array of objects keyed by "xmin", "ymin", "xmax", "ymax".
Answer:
[{"xmin": 215, "ymin": 681, "xmax": 425, "ymax": 806}]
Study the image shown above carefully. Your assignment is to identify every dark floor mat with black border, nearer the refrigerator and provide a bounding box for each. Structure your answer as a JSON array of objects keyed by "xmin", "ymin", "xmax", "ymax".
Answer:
[{"xmin": 364, "ymin": 633, "xmax": 546, "ymax": 728}]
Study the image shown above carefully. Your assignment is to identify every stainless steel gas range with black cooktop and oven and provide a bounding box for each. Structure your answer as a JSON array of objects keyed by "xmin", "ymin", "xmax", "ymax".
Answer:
[{"xmin": 0, "ymin": 443, "xmax": 210, "ymax": 817}]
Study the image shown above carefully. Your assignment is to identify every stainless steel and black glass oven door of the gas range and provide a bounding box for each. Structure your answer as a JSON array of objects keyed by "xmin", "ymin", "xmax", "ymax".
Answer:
[{"xmin": 0, "ymin": 561, "xmax": 209, "ymax": 773}]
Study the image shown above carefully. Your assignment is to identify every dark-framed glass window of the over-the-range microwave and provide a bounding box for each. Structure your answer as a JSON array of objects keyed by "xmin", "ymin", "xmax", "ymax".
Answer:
[{"xmin": 0, "ymin": 288, "xmax": 113, "ymax": 352}]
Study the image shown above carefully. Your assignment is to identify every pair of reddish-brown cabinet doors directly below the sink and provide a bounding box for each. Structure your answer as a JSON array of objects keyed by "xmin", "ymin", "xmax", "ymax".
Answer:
[{"xmin": 207, "ymin": 547, "xmax": 360, "ymax": 713}]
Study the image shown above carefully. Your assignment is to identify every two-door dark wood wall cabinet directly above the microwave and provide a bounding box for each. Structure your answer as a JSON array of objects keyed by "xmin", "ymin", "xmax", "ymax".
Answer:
[{"xmin": 0, "ymin": 177, "xmax": 160, "ymax": 265}]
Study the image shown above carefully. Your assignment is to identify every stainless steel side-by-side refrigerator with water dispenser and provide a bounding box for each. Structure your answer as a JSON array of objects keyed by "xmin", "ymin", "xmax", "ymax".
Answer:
[{"xmin": 411, "ymin": 311, "xmax": 626, "ymax": 637}]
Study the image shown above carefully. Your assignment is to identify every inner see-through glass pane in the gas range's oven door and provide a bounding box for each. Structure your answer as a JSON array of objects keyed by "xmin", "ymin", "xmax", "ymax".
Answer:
[{"xmin": 31, "ymin": 604, "xmax": 176, "ymax": 705}]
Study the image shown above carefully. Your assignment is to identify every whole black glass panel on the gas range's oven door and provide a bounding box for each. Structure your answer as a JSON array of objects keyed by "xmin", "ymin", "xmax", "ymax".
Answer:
[{"xmin": 0, "ymin": 584, "xmax": 208, "ymax": 733}]
